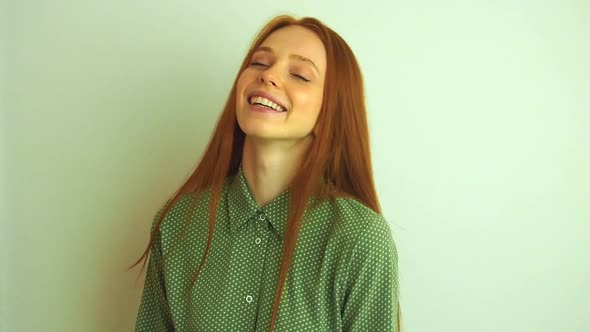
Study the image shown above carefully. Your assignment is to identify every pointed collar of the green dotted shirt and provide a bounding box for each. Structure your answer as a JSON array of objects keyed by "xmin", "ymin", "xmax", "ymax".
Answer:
[{"xmin": 227, "ymin": 165, "xmax": 290, "ymax": 240}]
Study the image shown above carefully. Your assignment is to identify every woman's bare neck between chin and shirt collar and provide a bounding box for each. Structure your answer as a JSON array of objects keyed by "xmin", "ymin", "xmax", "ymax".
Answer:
[{"xmin": 242, "ymin": 136, "xmax": 313, "ymax": 207}]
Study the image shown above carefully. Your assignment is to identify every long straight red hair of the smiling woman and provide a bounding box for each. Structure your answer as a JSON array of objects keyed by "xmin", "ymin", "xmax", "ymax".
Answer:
[{"xmin": 131, "ymin": 16, "xmax": 399, "ymax": 331}]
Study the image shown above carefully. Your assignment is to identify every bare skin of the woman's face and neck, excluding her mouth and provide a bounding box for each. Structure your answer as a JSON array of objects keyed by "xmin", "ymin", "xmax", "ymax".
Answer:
[{"xmin": 236, "ymin": 26, "xmax": 326, "ymax": 206}]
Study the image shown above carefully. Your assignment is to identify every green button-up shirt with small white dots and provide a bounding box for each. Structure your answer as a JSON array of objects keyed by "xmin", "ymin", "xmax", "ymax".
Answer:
[{"xmin": 135, "ymin": 167, "xmax": 398, "ymax": 332}]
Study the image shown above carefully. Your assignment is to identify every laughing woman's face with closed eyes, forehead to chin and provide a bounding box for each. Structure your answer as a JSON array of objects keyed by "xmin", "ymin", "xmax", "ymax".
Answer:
[{"xmin": 236, "ymin": 26, "xmax": 326, "ymax": 140}]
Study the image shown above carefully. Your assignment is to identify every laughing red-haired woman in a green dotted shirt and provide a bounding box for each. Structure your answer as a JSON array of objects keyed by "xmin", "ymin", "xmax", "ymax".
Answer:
[{"xmin": 134, "ymin": 16, "xmax": 399, "ymax": 332}]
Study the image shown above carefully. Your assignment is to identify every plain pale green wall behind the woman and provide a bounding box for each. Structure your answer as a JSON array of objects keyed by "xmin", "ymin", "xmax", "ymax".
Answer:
[{"xmin": 0, "ymin": 0, "xmax": 590, "ymax": 332}]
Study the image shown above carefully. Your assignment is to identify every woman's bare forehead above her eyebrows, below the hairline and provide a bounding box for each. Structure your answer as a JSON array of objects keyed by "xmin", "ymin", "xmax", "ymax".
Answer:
[{"xmin": 260, "ymin": 25, "xmax": 326, "ymax": 71}]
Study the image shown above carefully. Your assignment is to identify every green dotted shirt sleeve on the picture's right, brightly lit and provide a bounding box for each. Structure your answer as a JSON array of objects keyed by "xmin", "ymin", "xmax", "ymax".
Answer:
[{"xmin": 342, "ymin": 217, "xmax": 399, "ymax": 332}]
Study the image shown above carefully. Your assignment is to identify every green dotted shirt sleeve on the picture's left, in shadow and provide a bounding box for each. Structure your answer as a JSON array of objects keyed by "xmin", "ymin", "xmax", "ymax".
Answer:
[{"xmin": 135, "ymin": 208, "xmax": 174, "ymax": 332}]
